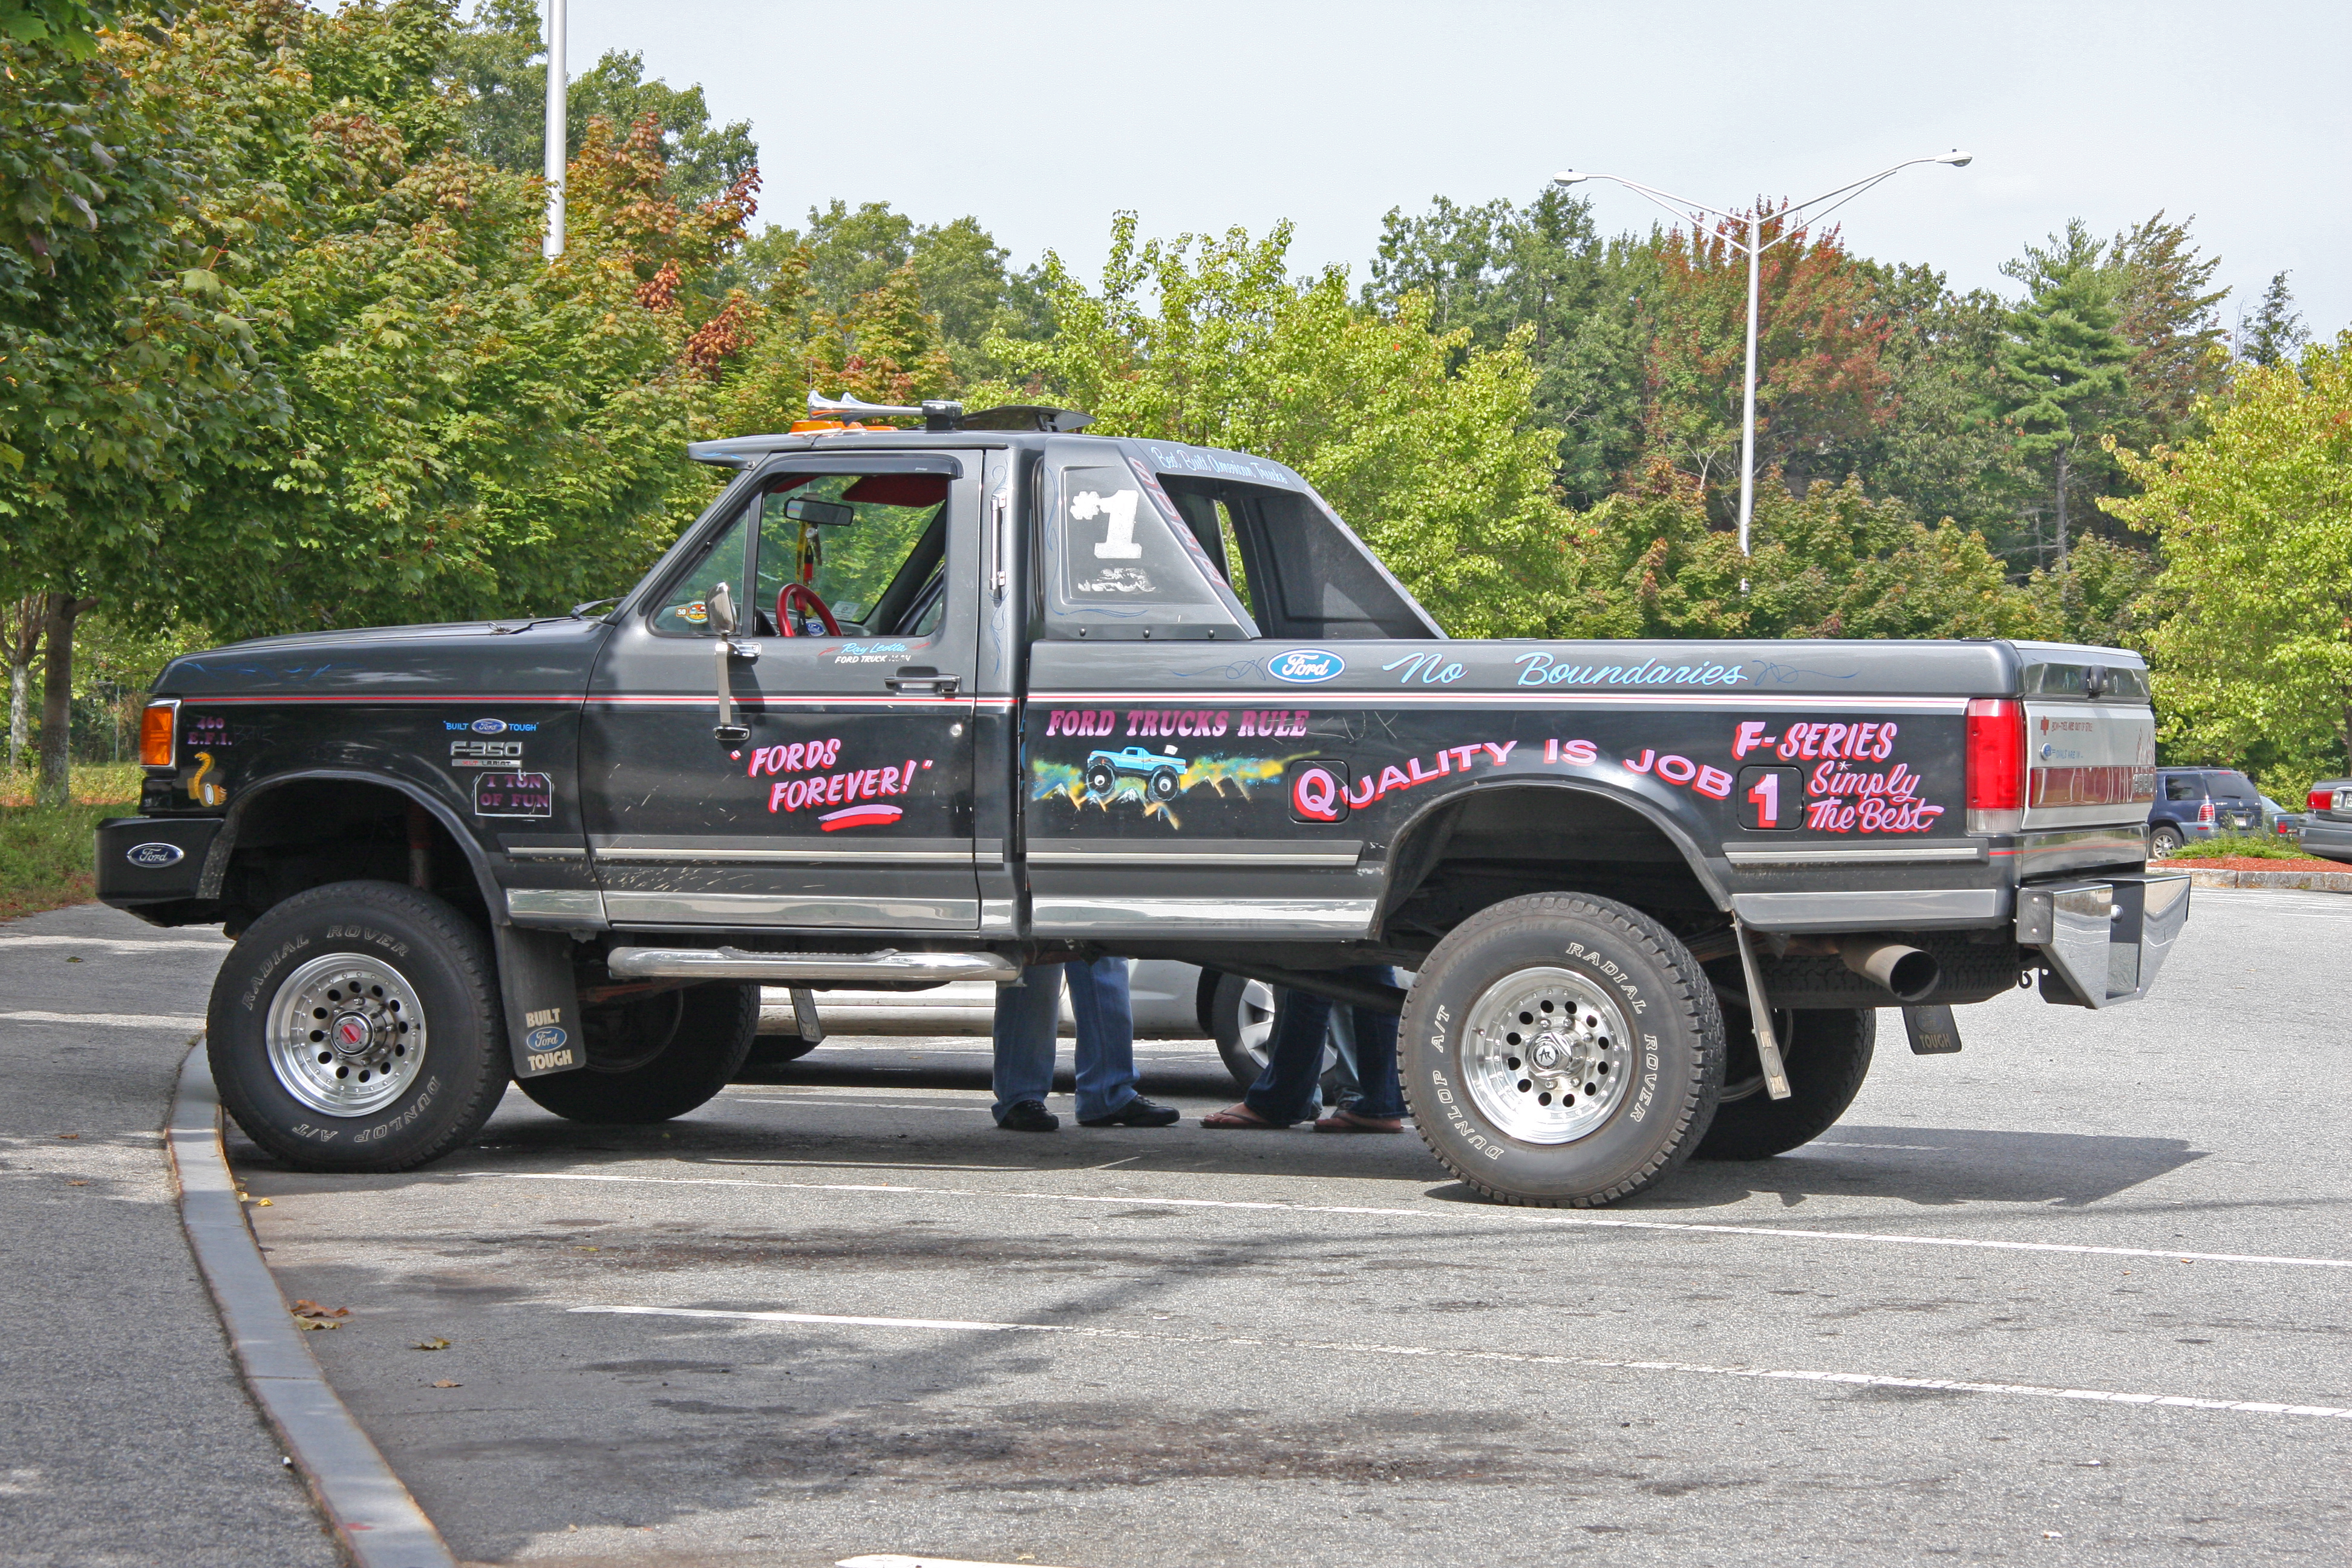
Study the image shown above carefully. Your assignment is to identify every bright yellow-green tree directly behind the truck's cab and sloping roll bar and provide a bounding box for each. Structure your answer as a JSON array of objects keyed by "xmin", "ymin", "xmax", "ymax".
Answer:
[{"xmin": 972, "ymin": 214, "xmax": 1566, "ymax": 635}]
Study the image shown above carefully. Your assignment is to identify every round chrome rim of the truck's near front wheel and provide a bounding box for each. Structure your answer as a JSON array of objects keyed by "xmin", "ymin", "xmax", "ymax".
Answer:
[{"xmin": 268, "ymin": 952, "xmax": 426, "ymax": 1117}]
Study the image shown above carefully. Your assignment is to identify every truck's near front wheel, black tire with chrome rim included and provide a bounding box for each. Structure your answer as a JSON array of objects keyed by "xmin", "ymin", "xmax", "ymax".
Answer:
[{"xmin": 204, "ymin": 881, "xmax": 508, "ymax": 1171}]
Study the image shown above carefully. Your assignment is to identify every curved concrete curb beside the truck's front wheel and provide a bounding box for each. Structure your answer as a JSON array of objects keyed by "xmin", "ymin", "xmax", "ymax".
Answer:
[{"xmin": 165, "ymin": 1042, "xmax": 456, "ymax": 1568}]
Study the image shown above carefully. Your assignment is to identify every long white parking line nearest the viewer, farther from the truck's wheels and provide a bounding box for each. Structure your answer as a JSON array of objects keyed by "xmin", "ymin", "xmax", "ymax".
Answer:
[{"xmin": 569, "ymin": 1307, "xmax": 2352, "ymax": 1420}]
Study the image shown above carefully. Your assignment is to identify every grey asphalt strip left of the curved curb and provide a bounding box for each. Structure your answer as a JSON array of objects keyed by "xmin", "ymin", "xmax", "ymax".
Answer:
[{"xmin": 0, "ymin": 905, "xmax": 336, "ymax": 1568}]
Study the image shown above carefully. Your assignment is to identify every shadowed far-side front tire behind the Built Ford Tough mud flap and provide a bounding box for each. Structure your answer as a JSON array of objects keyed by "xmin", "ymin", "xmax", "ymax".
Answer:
[{"xmin": 522, "ymin": 980, "xmax": 760, "ymax": 1124}]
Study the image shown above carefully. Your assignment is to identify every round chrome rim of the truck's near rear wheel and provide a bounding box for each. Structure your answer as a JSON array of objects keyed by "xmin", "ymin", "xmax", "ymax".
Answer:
[{"xmin": 1463, "ymin": 969, "xmax": 1632, "ymax": 1143}]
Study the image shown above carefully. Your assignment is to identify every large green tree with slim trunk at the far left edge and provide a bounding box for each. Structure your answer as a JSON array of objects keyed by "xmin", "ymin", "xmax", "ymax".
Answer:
[{"xmin": 0, "ymin": 6, "xmax": 299, "ymax": 804}]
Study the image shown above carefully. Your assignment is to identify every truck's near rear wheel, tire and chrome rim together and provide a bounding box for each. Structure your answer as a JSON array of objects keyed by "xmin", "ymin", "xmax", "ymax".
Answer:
[{"xmin": 1397, "ymin": 893, "xmax": 1724, "ymax": 1208}]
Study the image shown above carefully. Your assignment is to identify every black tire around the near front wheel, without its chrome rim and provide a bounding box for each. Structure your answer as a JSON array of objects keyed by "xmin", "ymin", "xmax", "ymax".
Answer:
[{"xmin": 204, "ymin": 881, "xmax": 511, "ymax": 1171}]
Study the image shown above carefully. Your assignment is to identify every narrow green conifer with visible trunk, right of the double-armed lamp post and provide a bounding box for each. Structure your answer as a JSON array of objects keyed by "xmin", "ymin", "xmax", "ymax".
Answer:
[{"xmin": 1994, "ymin": 218, "xmax": 2133, "ymax": 571}]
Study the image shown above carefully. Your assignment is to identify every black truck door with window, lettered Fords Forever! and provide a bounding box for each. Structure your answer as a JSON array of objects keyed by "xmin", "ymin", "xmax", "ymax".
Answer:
[{"xmin": 581, "ymin": 454, "xmax": 978, "ymax": 931}]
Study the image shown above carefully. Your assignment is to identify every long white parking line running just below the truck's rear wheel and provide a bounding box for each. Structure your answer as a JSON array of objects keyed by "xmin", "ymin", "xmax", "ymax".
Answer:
[{"xmin": 477, "ymin": 1161, "xmax": 2352, "ymax": 1269}]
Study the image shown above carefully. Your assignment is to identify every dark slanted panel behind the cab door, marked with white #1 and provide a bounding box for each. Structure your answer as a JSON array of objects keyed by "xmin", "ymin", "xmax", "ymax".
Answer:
[{"xmin": 1044, "ymin": 463, "xmax": 1249, "ymax": 637}]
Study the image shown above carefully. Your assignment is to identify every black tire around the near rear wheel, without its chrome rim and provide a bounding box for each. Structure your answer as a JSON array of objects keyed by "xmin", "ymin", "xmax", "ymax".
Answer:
[{"xmin": 1397, "ymin": 893, "xmax": 1724, "ymax": 1208}]
